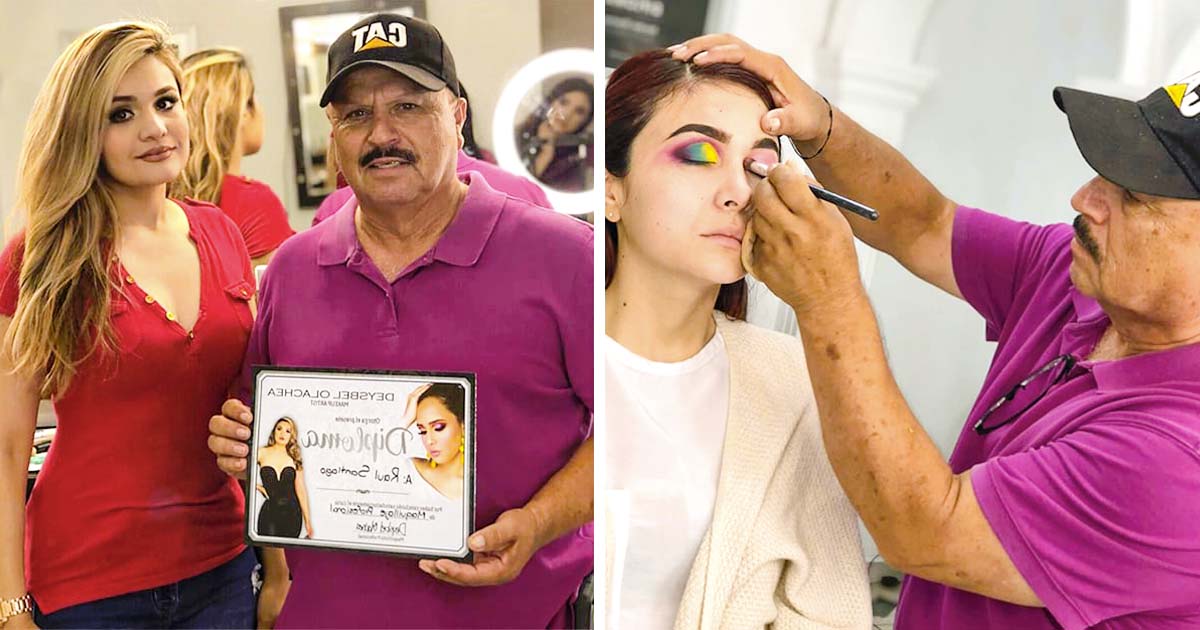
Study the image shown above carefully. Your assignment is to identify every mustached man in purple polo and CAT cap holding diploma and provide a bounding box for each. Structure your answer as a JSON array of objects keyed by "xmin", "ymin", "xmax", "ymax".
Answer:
[{"xmin": 209, "ymin": 13, "xmax": 593, "ymax": 628}]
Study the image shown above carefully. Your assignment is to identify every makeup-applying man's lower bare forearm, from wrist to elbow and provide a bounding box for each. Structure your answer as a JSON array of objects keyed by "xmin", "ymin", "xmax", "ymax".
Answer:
[{"xmin": 798, "ymin": 288, "xmax": 956, "ymax": 565}]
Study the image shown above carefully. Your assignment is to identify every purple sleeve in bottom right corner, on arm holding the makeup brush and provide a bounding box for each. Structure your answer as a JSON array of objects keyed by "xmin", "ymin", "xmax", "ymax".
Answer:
[{"xmin": 971, "ymin": 412, "xmax": 1200, "ymax": 629}]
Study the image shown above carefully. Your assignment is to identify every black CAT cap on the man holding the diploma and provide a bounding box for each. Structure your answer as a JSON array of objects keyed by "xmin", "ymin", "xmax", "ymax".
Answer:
[{"xmin": 320, "ymin": 13, "xmax": 458, "ymax": 107}]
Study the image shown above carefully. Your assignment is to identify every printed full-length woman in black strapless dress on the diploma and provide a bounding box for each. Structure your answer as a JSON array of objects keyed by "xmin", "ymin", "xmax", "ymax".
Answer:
[{"xmin": 257, "ymin": 418, "xmax": 312, "ymax": 538}]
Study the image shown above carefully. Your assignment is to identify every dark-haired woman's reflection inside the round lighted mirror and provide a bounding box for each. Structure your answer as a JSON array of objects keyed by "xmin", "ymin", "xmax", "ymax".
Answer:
[{"xmin": 514, "ymin": 72, "xmax": 595, "ymax": 192}]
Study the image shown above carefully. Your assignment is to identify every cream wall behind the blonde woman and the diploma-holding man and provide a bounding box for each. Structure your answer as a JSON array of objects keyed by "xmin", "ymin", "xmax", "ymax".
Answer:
[{"xmin": 0, "ymin": 0, "xmax": 541, "ymax": 229}]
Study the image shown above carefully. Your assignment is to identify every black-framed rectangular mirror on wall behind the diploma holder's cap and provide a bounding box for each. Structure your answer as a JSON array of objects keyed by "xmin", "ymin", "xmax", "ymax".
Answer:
[{"xmin": 280, "ymin": 0, "xmax": 425, "ymax": 208}]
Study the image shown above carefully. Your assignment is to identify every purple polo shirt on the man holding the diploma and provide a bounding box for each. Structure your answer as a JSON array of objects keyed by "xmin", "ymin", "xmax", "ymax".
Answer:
[{"xmin": 242, "ymin": 173, "xmax": 594, "ymax": 628}]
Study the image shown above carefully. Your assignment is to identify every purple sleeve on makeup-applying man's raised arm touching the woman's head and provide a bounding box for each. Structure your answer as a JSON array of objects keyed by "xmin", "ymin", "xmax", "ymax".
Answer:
[{"xmin": 950, "ymin": 205, "xmax": 1073, "ymax": 341}]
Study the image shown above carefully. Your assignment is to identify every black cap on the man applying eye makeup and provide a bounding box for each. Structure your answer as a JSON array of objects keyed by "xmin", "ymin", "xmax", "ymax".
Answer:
[{"xmin": 1054, "ymin": 72, "xmax": 1200, "ymax": 199}]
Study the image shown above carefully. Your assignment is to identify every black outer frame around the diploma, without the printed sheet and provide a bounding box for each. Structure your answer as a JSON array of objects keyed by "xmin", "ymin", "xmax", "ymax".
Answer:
[{"xmin": 242, "ymin": 365, "xmax": 479, "ymax": 564}]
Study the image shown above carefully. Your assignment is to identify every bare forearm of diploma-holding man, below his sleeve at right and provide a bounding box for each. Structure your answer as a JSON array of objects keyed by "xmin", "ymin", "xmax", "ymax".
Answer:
[{"xmin": 524, "ymin": 438, "xmax": 594, "ymax": 548}]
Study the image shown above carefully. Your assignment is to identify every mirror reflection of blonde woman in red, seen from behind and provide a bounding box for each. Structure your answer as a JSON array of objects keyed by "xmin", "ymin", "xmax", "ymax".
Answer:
[{"xmin": 170, "ymin": 48, "xmax": 295, "ymax": 265}]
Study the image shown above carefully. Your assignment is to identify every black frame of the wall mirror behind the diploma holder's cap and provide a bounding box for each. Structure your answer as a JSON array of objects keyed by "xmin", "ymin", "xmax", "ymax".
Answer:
[{"xmin": 280, "ymin": 0, "xmax": 425, "ymax": 208}]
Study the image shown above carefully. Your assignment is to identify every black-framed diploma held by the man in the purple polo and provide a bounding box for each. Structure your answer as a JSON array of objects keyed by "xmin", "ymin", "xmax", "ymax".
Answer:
[{"xmin": 246, "ymin": 366, "xmax": 475, "ymax": 560}]
